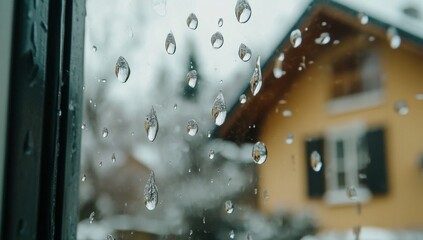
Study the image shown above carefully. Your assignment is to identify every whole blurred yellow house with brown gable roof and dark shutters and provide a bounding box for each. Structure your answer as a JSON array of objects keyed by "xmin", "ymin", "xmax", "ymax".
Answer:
[{"xmin": 218, "ymin": 0, "xmax": 423, "ymax": 230}]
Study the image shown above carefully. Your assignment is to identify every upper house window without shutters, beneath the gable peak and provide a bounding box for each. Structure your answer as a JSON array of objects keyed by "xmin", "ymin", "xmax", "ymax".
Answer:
[{"xmin": 327, "ymin": 49, "xmax": 383, "ymax": 114}]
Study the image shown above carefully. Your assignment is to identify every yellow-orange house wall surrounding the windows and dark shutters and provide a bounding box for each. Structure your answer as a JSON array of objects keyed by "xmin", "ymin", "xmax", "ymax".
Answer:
[{"xmin": 258, "ymin": 39, "xmax": 423, "ymax": 230}]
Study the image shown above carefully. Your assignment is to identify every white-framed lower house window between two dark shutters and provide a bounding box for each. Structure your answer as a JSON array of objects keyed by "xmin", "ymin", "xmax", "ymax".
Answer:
[{"xmin": 324, "ymin": 121, "xmax": 371, "ymax": 205}]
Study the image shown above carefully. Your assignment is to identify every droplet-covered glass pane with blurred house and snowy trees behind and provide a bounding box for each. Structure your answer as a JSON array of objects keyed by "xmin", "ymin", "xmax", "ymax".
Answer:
[{"xmin": 78, "ymin": 0, "xmax": 423, "ymax": 240}]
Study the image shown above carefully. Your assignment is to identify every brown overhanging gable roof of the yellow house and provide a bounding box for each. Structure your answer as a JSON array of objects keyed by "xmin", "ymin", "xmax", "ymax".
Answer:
[{"xmin": 215, "ymin": 0, "xmax": 423, "ymax": 143}]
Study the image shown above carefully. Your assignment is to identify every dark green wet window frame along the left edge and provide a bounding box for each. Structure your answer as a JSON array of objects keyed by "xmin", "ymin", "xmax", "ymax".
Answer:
[{"xmin": 0, "ymin": 0, "xmax": 85, "ymax": 240}]
